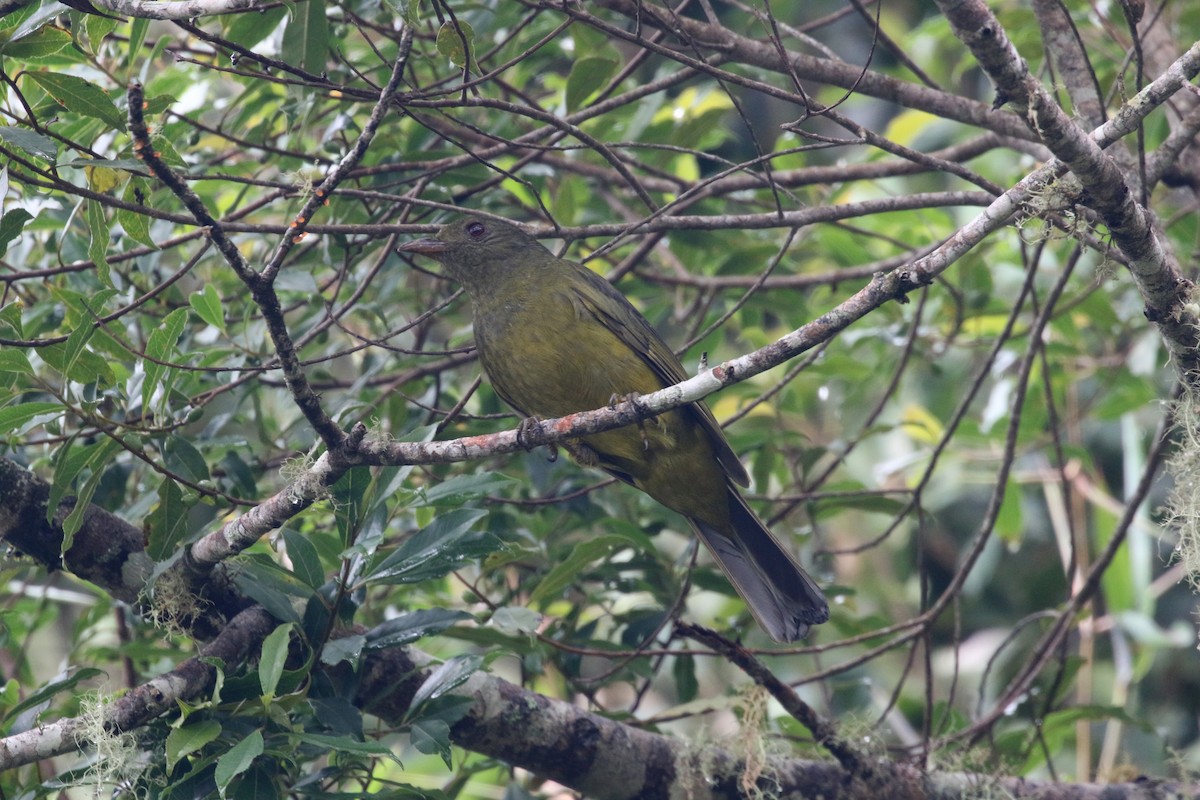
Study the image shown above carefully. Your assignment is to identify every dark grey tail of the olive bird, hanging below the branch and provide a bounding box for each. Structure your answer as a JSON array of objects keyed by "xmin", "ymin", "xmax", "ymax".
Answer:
[{"xmin": 689, "ymin": 487, "xmax": 829, "ymax": 642}]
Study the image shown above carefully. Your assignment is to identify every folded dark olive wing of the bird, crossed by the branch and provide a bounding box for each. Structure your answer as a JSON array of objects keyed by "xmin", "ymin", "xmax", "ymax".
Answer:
[{"xmin": 568, "ymin": 261, "xmax": 750, "ymax": 486}]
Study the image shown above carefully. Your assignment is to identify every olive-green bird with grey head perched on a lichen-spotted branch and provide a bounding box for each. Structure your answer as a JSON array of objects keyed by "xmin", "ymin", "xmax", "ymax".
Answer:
[{"xmin": 398, "ymin": 216, "xmax": 829, "ymax": 642}]
